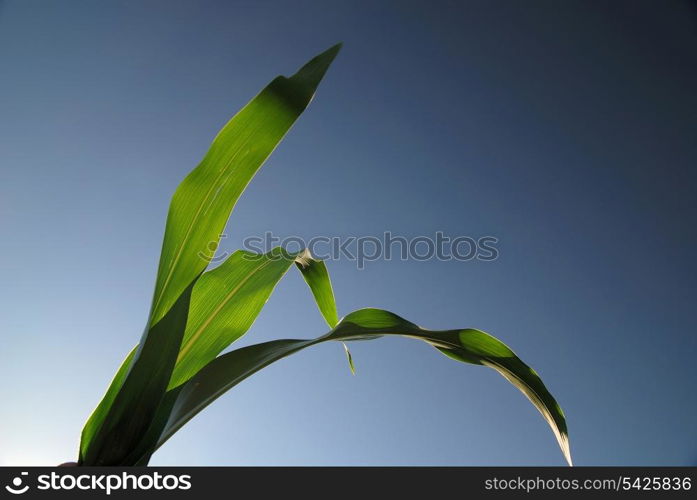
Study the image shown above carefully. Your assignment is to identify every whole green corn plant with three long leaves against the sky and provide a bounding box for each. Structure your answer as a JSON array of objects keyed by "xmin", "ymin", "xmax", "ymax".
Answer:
[{"xmin": 78, "ymin": 45, "xmax": 571, "ymax": 465}]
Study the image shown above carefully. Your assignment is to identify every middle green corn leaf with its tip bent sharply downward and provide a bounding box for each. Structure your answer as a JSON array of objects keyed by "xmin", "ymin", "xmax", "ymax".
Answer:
[{"xmin": 81, "ymin": 247, "xmax": 340, "ymax": 463}]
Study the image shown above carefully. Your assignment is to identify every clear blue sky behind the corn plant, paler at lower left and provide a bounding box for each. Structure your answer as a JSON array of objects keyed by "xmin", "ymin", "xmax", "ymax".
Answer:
[{"xmin": 0, "ymin": 0, "xmax": 697, "ymax": 465}]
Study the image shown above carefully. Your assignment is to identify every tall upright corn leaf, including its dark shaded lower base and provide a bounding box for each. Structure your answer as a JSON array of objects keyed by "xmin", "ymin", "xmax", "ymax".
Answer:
[{"xmin": 80, "ymin": 45, "xmax": 340, "ymax": 464}]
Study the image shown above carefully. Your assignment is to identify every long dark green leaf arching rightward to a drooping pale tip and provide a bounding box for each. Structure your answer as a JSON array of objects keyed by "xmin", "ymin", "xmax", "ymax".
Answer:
[{"xmin": 155, "ymin": 309, "xmax": 571, "ymax": 464}]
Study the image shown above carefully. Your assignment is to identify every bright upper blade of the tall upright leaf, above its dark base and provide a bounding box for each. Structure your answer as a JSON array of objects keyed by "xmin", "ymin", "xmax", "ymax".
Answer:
[{"xmin": 151, "ymin": 45, "xmax": 340, "ymax": 323}]
